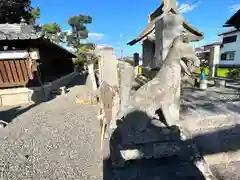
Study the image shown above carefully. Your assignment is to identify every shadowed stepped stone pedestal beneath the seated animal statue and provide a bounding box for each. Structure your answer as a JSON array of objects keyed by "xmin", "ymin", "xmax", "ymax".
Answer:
[{"xmin": 111, "ymin": 120, "xmax": 191, "ymax": 167}]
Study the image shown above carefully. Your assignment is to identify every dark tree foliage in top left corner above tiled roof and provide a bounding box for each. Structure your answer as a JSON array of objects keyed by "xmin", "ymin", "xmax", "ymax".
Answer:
[{"xmin": 0, "ymin": 0, "xmax": 37, "ymax": 24}]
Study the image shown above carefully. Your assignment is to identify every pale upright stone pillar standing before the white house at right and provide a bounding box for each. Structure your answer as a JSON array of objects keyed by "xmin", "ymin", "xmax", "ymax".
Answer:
[{"xmin": 208, "ymin": 45, "xmax": 220, "ymax": 77}]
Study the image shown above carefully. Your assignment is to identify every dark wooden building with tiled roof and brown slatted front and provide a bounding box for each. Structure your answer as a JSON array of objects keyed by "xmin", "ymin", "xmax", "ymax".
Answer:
[{"xmin": 0, "ymin": 23, "xmax": 76, "ymax": 88}]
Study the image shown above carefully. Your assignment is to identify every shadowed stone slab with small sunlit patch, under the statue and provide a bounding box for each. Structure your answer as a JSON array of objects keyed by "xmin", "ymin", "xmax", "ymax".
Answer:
[{"xmin": 111, "ymin": 141, "xmax": 192, "ymax": 167}]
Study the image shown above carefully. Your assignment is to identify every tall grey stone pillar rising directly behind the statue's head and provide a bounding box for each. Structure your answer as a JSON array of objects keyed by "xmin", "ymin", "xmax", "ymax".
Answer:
[{"xmin": 155, "ymin": 13, "xmax": 183, "ymax": 68}]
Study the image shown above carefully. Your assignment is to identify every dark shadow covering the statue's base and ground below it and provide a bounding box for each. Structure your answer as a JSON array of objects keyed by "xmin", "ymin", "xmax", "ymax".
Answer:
[{"xmin": 103, "ymin": 111, "xmax": 205, "ymax": 180}]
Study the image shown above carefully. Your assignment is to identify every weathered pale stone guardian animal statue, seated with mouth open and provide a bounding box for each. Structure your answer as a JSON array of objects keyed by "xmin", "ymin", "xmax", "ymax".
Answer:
[{"xmin": 118, "ymin": 35, "xmax": 200, "ymax": 126}]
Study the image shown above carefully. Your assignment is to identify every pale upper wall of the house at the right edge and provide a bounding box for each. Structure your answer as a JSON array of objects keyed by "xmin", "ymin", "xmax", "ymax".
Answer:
[{"xmin": 219, "ymin": 32, "xmax": 240, "ymax": 65}]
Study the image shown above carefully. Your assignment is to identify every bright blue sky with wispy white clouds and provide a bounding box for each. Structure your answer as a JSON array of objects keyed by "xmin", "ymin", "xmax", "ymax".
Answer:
[{"xmin": 32, "ymin": 0, "xmax": 240, "ymax": 56}]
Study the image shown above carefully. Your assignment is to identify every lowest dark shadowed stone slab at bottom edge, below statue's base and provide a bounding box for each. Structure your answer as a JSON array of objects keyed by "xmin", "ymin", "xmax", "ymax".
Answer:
[{"xmin": 112, "ymin": 157, "xmax": 216, "ymax": 180}]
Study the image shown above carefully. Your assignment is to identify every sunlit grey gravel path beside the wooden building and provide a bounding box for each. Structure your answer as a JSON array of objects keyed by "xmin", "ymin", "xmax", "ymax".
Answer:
[{"xmin": 0, "ymin": 74, "xmax": 102, "ymax": 180}]
